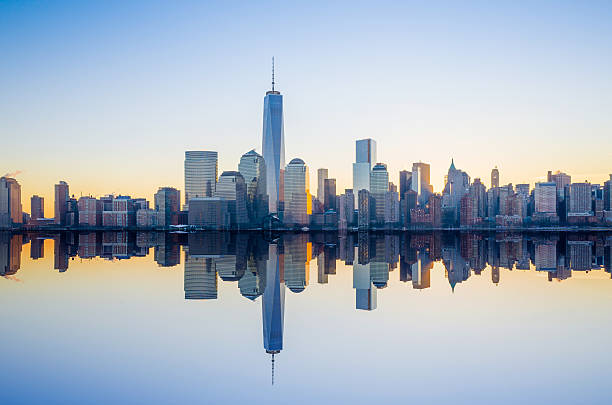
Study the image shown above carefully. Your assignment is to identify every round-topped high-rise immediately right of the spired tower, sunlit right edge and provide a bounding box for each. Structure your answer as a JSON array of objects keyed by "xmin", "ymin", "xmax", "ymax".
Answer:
[{"xmin": 283, "ymin": 158, "xmax": 312, "ymax": 225}]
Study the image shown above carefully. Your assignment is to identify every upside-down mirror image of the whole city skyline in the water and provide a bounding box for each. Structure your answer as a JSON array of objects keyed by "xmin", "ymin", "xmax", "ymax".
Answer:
[{"xmin": 0, "ymin": 232, "xmax": 612, "ymax": 382}]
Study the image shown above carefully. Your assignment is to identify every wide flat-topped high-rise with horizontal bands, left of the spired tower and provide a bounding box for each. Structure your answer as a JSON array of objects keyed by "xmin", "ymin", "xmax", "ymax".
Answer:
[{"xmin": 184, "ymin": 150, "xmax": 219, "ymax": 210}]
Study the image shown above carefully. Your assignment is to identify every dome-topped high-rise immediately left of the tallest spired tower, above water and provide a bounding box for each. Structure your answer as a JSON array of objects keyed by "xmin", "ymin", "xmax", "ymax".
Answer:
[{"xmin": 238, "ymin": 150, "xmax": 268, "ymax": 225}]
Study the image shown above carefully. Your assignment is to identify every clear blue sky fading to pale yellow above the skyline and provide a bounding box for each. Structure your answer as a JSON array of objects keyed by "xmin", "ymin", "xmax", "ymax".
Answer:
[{"xmin": 0, "ymin": 1, "xmax": 612, "ymax": 216}]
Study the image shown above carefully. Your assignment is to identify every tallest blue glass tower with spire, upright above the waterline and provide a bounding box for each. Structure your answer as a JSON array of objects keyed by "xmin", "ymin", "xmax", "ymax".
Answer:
[{"xmin": 262, "ymin": 59, "xmax": 285, "ymax": 213}]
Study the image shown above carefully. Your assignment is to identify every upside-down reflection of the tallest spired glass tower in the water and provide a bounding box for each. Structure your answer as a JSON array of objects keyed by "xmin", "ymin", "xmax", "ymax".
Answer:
[{"xmin": 261, "ymin": 243, "xmax": 285, "ymax": 384}]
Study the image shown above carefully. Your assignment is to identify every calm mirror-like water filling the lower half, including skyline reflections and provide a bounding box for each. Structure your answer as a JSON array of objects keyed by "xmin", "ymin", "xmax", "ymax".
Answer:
[{"xmin": 0, "ymin": 233, "xmax": 612, "ymax": 404}]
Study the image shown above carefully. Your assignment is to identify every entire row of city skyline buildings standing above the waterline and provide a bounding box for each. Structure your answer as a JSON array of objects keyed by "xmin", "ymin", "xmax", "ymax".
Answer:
[{"xmin": 0, "ymin": 71, "xmax": 612, "ymax": 230}]
